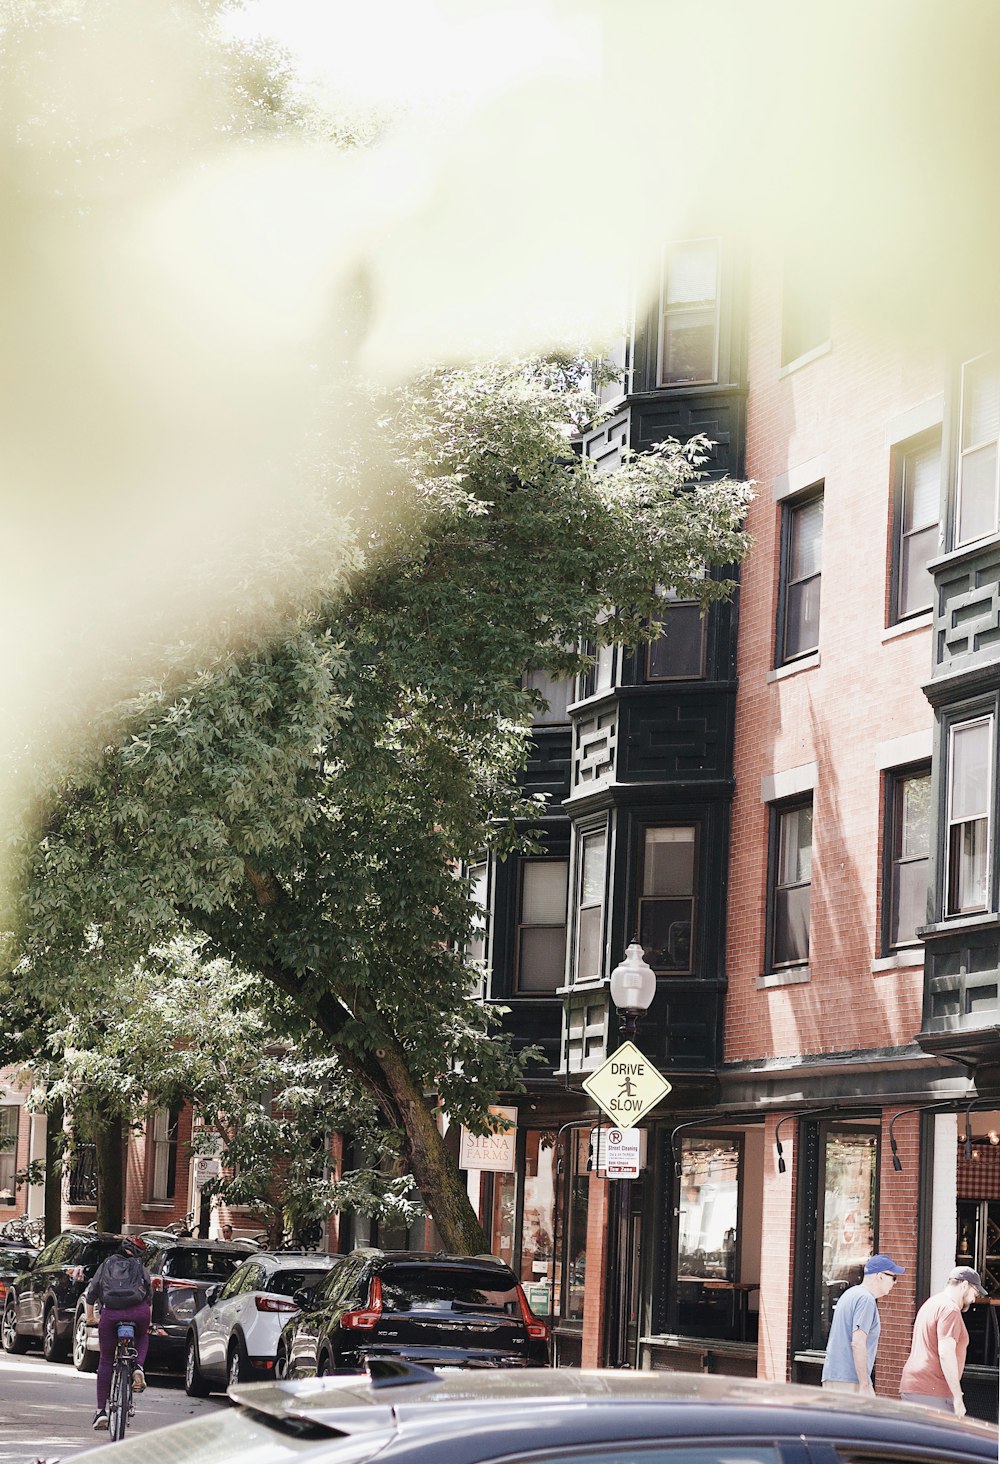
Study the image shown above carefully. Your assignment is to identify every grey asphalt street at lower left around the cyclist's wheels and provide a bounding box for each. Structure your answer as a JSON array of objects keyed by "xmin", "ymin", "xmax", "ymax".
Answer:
[{"xmin": 0, "ymin": 1353, "xmax": 228, "ymax": 1464}]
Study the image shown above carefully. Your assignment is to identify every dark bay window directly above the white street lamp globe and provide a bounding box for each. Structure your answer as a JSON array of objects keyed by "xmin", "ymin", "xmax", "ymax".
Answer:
[{"xmin": 638, "ymin": 827, "xmax": 695, "ymax": 974}]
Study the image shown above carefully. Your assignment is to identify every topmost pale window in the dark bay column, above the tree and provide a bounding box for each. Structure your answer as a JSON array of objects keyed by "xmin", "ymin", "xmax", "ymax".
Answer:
[{"xmin": 657, "ymin": 239, "xmax": 719, "ymax": 386}]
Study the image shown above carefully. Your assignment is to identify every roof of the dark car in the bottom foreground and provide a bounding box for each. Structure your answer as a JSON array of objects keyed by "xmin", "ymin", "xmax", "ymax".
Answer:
[{"xmin": 230, "ymin": 1362, "xmax": 997, "ymax": 1460}]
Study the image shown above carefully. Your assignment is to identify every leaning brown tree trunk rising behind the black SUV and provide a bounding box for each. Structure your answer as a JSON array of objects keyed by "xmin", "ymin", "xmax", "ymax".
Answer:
[{"xmin": 375, "ymin": 1045, "xmax": 489, "ymax": 1256}]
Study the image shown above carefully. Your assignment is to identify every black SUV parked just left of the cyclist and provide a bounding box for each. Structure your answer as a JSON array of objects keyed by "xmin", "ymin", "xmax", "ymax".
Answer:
[{"xmin": 0, "ymin": 1230, "xmax": 122, "ymax": 1363}]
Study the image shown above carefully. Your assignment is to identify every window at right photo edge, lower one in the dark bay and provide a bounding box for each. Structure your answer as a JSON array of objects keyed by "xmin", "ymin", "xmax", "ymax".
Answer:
[{"xmin": 944, "ymin": 716, "xmax": 993, "ymax": 915}]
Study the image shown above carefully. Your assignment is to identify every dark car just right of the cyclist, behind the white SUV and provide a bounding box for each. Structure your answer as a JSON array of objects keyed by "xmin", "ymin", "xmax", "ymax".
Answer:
[{"xmin": 146, "ymin": 1240, "xmax": 256, "ymax": 1372}]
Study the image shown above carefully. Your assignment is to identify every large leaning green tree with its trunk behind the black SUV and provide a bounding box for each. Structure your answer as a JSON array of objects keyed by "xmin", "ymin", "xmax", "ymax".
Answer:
[{"xmin": 6, "ymin": 362, "xmax": 748, "ymax": 1252}]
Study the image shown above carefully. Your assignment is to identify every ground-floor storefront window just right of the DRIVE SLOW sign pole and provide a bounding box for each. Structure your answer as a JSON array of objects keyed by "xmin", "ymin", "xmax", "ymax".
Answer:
[{"xmin": 676, "ymin": 1135, "xmax": 745, "ymax": 1341}]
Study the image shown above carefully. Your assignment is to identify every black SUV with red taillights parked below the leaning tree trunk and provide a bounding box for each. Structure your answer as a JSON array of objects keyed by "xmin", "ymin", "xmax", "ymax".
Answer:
[{"xmin": 275, "ymin": 1250, "xmax": 549, "ymax": 1378}]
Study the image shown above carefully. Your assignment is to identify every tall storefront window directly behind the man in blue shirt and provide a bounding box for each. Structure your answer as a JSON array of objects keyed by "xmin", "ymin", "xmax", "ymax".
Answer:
[{"xmin": 814, "ymin": 1129, "xmax": 878, "ymax": 1347}]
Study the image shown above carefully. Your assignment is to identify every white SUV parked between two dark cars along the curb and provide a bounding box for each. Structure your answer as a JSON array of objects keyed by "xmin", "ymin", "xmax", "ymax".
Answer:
[{"xmin": 184, "ymin": 1250, "xmax": 344, "ymax": 1398}]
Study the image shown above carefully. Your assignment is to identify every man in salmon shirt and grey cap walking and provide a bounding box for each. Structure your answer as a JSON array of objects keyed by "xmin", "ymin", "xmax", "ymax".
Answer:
[{"xmin": 899, "ymin": 1266, "xmax": 987, "ymax": 1417}]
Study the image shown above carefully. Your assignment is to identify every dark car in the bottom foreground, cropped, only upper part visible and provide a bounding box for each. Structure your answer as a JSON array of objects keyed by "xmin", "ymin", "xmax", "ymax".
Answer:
[{"xmin": 72, "ymin": 1359, "xmax": 997, "ymax": 1464}]
